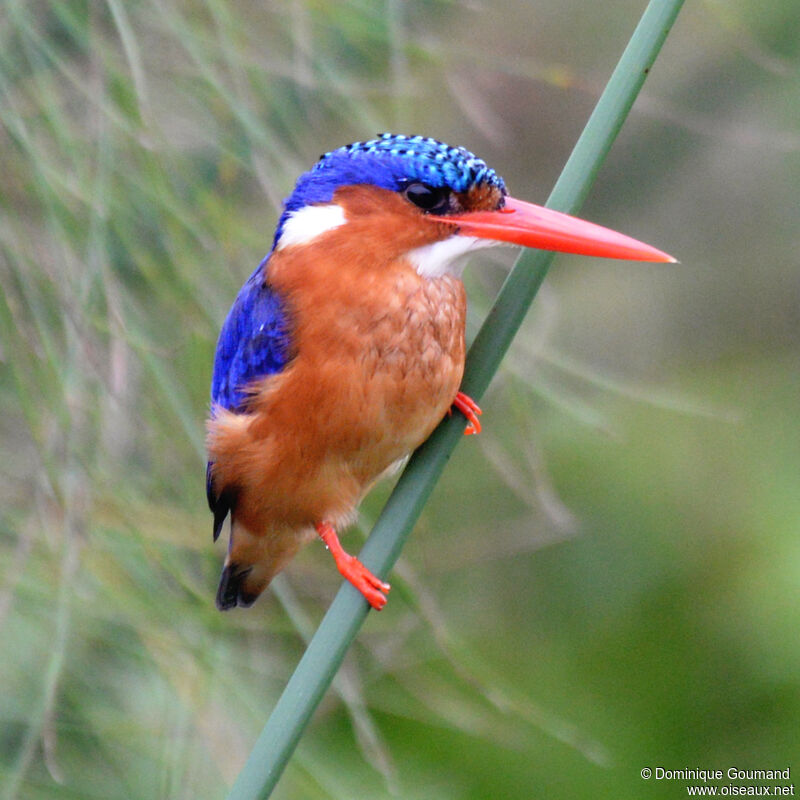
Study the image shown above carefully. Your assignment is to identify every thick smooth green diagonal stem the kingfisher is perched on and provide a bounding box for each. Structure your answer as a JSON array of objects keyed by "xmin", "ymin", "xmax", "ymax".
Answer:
[{"xmin": 228, "ymin": 0, "xmax": 683, "ymax": 800}]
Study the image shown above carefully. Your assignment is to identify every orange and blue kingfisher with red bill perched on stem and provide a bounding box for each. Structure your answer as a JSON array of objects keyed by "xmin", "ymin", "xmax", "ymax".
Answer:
[{"xmin": 206, "ymin": 133, "xmax": 674, "ymax": 610}]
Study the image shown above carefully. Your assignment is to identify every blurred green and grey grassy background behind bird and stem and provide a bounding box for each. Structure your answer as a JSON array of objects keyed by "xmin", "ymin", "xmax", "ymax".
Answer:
[{"xmin": 0, "ymin": 0, "xmax": 800, "ymax": 800}]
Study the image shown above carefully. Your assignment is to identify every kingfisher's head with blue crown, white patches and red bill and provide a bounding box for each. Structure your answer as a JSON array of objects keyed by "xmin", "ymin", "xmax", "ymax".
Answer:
[{"xmin": 273, "ymin": 133, "xmax": 675, "ymax": 277}]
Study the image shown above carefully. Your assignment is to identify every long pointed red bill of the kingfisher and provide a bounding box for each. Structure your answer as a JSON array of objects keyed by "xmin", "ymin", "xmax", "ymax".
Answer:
[{"xmin": 428, "ymin": 197, "xmax": 675, "ymax": 262}]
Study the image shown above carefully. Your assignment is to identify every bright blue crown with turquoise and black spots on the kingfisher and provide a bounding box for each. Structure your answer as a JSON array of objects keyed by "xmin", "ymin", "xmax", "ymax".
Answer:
[{"xmin": 273, "ymin": 133, "xmax": 506, "ymax": 248}]
